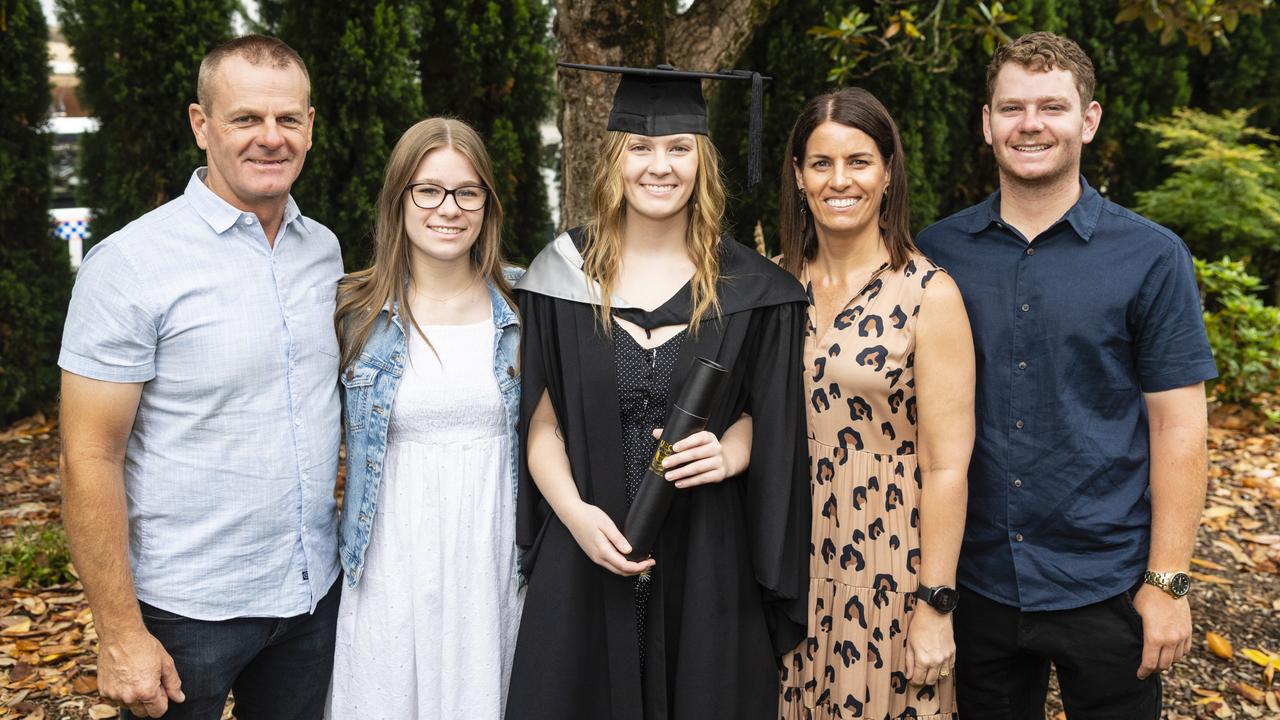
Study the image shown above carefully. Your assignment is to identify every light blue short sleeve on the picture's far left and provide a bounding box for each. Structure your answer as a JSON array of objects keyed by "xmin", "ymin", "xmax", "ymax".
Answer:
[{"xmin": 58, "ymin": 245, "xmax": 157, "ymax": 383}]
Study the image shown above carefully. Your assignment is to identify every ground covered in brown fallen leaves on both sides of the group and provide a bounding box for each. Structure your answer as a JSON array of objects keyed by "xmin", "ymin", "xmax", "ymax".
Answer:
[{"xmin": 0, "ymin": 397, "xmax": 1280, "ymax": 720}]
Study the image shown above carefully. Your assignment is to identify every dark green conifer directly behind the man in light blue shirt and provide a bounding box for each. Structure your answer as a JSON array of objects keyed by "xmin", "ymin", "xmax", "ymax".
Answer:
[{"xmin": 56, "ymin": 0, "xmax": 238, "ymax": 243}]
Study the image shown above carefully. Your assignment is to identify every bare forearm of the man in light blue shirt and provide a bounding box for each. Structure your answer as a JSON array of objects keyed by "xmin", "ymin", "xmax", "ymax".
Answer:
[{"xmin": 63, "ymin": 451, "xmax": 143, "ymax": 641}]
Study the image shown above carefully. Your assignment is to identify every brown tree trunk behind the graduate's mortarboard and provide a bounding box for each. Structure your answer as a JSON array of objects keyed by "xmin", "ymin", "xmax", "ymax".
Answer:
[{"xmin": 554, "ymin": 0, "xmax": 774, "ymax": 229}]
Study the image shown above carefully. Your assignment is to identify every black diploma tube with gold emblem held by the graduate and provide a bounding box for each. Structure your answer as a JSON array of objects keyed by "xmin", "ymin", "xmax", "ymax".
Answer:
[{"xmin": 622, "ymin": 357, "xmax": 728, "ymax": 562}]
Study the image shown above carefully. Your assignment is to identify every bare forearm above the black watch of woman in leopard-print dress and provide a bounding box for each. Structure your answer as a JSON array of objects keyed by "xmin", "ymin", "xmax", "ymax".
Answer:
[{"xmin": 920, "ymin": 469, "xmax": 969, "ymax": 587}]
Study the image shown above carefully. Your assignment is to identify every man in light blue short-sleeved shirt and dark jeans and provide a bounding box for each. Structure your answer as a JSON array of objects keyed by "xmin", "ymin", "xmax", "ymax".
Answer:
[{"xmin": 59, "ymin": 36, "xmax": 342, "ymax": 720}]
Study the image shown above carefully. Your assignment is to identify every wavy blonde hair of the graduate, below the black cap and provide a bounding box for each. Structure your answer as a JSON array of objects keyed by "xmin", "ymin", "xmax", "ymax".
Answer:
[{"xmin": 582, "ymin": 132, "xmax": 726, "ymax": 337}]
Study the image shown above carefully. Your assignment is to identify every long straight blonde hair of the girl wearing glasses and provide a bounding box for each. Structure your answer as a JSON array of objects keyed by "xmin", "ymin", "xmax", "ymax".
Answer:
[{"xmin": 334, "ymin": 118, "xmax": 515, "ymax": 368}]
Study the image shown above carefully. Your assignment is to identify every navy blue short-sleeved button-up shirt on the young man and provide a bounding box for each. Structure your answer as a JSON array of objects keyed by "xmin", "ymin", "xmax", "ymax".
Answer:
[{"xmin": 918, "ymin": 178, "xmax": 1217, "ymax": 611}]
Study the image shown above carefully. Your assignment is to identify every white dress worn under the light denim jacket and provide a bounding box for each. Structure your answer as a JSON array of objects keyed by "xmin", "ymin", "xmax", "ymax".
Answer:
[{"xmin": 325, "ymin": 319, "xmax": 524, "ymax": 720}]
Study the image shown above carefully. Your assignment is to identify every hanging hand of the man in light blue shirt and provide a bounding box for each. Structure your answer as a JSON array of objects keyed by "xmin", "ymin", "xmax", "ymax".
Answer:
[{"xmin": 97, "ymin": 629, "xmax": 187, "ymax": 717}]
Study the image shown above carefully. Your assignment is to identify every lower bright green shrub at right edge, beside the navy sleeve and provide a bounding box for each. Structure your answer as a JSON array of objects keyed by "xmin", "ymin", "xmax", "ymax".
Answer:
[{"xmin": 1196, "ymin": 258, "xmax": 1280, "ymax": 404}]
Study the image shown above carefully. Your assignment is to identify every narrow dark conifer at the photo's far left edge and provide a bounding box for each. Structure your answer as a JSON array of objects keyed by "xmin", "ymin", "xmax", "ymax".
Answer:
[{"xmin": 0, "ymin": 0, "xmax": 72, "ymax": 421}]
